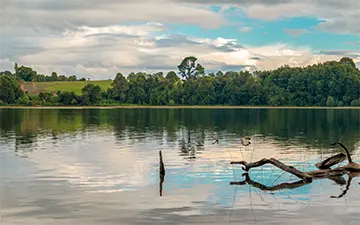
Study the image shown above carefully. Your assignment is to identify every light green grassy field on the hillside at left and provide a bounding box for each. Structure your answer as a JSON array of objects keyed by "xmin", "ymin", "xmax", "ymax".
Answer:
[{"xmin": 20, "ymin": 80, "xmax": 112, "ymax": 94}]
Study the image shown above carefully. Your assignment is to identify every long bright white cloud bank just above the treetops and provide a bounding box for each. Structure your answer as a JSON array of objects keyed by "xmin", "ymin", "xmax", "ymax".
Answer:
[{"xmin": 0, "ymin": 25, "xmax": 360, "ymax": 79}]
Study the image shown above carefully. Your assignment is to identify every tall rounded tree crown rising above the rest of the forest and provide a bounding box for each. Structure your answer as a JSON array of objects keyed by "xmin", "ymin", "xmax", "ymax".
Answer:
[{"xmin": 178, "ymin": 56, "xmax": 205, "ymax": 80}]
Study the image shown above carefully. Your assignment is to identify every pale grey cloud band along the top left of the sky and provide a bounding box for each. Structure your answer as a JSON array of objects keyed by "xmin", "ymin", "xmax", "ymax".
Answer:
[{"xmin": 0, "ymin": 0, "xmax": 225, "ymax": 30}]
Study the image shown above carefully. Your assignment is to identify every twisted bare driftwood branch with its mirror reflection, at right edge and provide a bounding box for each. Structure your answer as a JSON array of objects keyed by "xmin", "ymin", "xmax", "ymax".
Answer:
[{"xmin": 230, "ymin": 142, "xmax": 360, "ymax": 184}]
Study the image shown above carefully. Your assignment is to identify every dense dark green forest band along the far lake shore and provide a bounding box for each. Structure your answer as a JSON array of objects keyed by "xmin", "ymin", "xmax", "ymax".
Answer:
[{"xmin": 0, "ymin": 56, "xmax": 360, "ymax": 106}]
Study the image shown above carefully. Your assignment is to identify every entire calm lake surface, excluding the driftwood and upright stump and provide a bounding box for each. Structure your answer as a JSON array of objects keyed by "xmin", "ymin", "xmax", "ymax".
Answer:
[{"xmin": 0, "ymin": 109, "xmax": 360, "ymax": 225}]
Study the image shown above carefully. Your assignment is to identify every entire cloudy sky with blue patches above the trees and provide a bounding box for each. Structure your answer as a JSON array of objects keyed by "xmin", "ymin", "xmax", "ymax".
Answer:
[{"xmin": 0, "ymin": 0, "xmax": 360, "ymax": 79}]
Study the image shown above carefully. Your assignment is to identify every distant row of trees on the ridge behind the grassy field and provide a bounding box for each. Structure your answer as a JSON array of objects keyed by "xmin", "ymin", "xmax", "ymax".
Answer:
[{"xmin": 0, "ymin": 63, "xmax": 86, "ymax": 82}]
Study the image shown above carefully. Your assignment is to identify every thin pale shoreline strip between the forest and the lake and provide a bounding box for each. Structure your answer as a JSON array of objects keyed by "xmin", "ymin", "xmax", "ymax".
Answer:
[{"xmin": 0, "ymin": 105, "xmax": 360, "ymax": 109}]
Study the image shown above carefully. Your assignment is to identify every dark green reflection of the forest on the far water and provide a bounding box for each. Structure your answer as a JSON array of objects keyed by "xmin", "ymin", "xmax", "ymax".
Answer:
[{"xmin": 0, "ymin": 109, "xmax": 360, "ymax": 154}]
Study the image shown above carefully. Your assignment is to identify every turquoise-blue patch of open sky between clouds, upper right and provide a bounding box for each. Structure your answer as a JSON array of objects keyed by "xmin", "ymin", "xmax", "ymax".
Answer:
[{"xmin": 170, "ymin": 7, "xmax": 360, "ymax": 51}]
